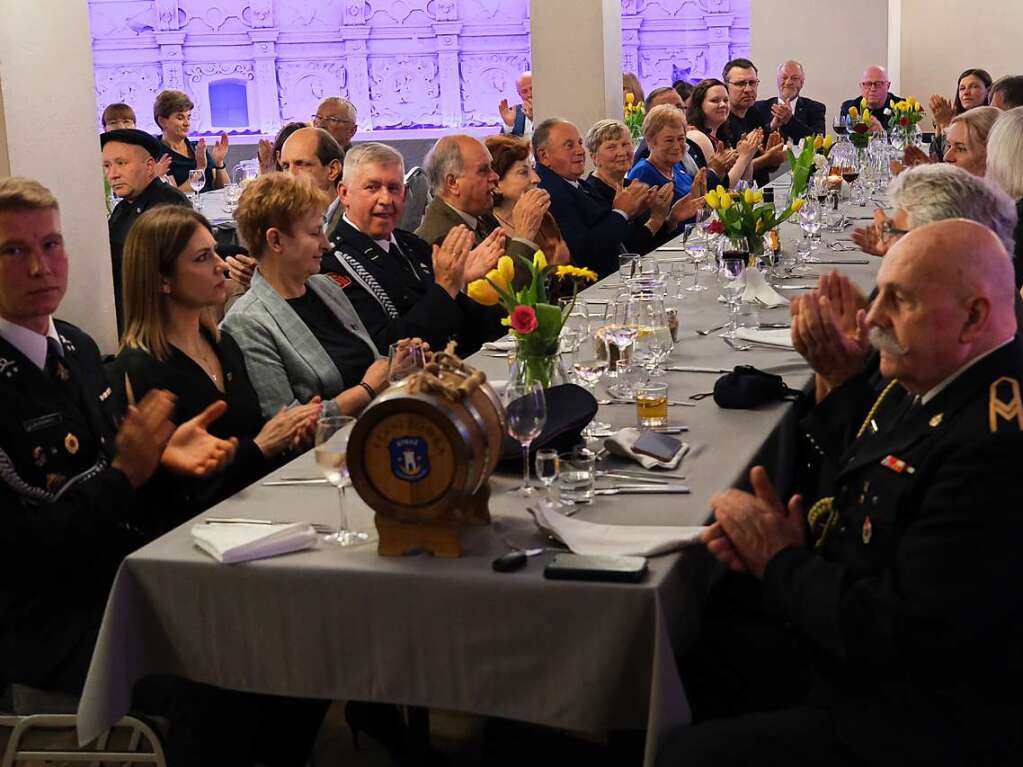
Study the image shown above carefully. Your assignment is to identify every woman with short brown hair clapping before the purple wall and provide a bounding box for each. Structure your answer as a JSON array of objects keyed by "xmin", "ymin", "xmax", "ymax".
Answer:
[{"xmin": 152, "ymin": 90, "xmax": 230, "ymax": 192}]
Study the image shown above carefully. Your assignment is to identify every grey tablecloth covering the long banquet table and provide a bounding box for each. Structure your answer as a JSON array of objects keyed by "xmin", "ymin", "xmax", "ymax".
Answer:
[{"xmin": 79, "ymin": 182, "xmax": 880, "ymax": 764}]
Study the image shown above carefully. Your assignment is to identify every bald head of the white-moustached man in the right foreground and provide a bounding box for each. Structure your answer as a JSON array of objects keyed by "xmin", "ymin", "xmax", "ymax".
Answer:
[{"xmin": 866, "ymin": 219, "xmax": 1016, "ymax": 395}]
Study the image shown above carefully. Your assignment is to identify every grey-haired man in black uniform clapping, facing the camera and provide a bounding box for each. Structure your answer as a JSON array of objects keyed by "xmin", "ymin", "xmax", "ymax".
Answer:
[{"xmin": 320, "ymin": 142, "xmax": 503, "ymax": 355}]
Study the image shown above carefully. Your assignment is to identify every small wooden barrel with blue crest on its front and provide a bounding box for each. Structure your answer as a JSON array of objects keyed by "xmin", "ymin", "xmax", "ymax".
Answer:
[{"xmin": 348, "ymin": 371, "xmax": 506, "ymax": 524}]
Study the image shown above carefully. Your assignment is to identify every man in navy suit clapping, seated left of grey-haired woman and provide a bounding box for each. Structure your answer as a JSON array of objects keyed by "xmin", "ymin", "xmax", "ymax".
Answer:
[{"xmin": 533, "ymin": 118, "xmax": 653, "ymax": 278}]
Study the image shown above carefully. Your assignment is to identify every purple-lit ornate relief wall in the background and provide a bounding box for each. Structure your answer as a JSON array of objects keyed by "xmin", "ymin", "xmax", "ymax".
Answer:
[{"xmin": 89, "ymin": 0, "xmax": 750, "ymax": 134}]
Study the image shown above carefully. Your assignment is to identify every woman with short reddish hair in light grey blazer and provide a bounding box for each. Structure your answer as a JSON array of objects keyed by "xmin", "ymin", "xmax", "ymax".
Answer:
[{"xmin": 221, "ymin": 173, "xmax": 387, "ymax": 417}]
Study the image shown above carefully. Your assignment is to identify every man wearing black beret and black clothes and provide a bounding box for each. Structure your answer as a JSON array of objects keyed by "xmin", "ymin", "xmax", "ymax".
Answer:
[{"xmin": 99, "ymin": 128, "xmax": 188, "ymax": 334}]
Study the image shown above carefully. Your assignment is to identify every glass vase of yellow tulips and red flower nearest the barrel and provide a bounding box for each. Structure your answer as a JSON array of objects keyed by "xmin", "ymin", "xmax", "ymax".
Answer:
[{"xmin": 465, "ymin": 251, "xmax": 596, "ymax": 389}]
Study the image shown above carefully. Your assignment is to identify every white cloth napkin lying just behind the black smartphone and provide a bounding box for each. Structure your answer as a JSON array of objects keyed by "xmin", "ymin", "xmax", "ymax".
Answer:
[{"xmin": 531, "ymin": 504, "xmax": 704, "ymax": 556}]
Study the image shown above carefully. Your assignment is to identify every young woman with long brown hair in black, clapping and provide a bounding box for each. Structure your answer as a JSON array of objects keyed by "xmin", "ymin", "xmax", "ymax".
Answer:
[{"xmin": 107, "ymin": 206, "xmax": 320, "ymax": 518}]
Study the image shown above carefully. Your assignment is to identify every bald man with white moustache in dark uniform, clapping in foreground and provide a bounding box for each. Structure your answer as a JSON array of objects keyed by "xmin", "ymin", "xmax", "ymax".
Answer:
[{"xmin": 663, "ymin": 219, "xmax": 1023, "ymax": 765}]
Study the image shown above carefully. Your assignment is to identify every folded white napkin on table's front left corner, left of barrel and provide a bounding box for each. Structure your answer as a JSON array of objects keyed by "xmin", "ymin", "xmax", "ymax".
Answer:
[{"xmin": 192, "ymin": 522, "xmax": 316, "ymax": 565}]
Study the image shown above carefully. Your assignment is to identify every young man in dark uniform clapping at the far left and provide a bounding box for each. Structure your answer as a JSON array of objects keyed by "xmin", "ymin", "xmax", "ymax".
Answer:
[{"xmin": 0, "ymin": 178, "xmax": 324, "ymax": 767}]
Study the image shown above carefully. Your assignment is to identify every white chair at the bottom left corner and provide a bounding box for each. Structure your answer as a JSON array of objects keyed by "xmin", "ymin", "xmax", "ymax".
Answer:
[{"xmin": 0, "ymin": 714, "xmax": 167, "ymax": 767}]
